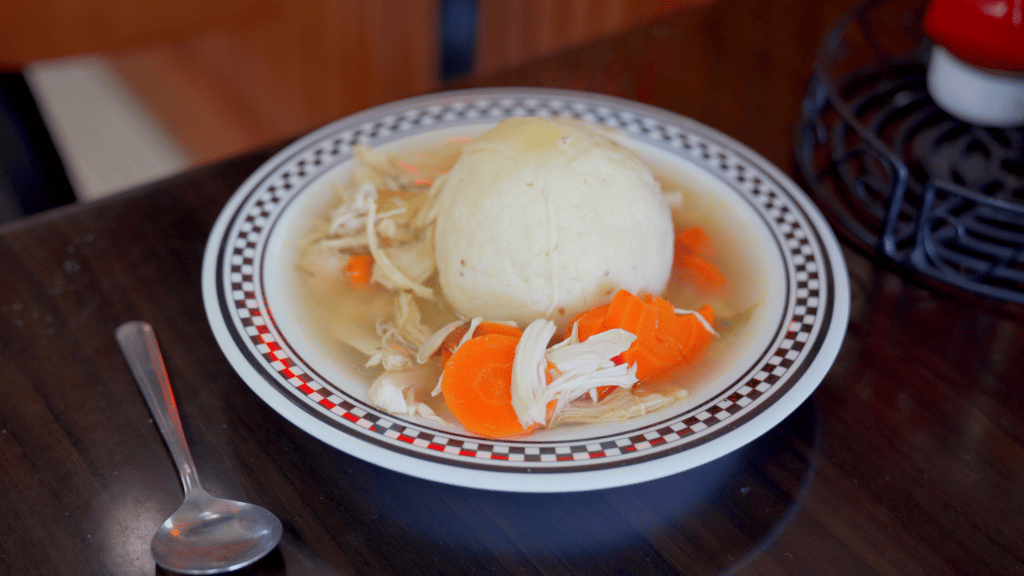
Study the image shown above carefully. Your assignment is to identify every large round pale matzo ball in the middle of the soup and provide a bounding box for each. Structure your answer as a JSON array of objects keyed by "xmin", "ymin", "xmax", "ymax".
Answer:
[{"xmin": 434, "ymin": 118, "xmax": 674, "ymax": 327}]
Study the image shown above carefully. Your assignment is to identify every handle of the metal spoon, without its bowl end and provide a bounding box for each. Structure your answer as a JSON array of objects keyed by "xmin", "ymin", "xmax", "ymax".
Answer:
[{"xmin": 115, "ymin": 320, "xmax": 202, "ymax": 496}]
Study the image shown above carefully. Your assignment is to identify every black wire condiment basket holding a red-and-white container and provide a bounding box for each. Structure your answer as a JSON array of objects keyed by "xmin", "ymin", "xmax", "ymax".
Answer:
[{"xmin": 796, "ymin": 0, "xmax": 1024, "ymax": 303}]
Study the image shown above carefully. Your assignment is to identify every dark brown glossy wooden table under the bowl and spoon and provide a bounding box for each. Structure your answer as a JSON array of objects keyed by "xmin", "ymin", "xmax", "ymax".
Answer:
[{"xmin": 0, "ymin": 0, "xmax": 1024, "ymax": 576}]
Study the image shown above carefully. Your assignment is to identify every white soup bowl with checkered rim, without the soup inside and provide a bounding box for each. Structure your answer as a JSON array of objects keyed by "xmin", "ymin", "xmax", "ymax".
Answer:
[{"xmin": 197, "ymin": 88, "xmax": 850, "ymax": 492}]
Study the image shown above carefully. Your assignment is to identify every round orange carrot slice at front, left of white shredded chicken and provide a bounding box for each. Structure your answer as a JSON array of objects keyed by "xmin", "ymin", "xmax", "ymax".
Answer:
[{"xmin": 441, "ymin": 334, "xmax": 534, "ymax": 438}]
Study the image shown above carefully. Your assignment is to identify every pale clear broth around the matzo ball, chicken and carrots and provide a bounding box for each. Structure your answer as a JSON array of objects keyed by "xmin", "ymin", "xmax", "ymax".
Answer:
[{"xmin": 291, "ymin": 129, "xmax": 770, "ymax": 430}]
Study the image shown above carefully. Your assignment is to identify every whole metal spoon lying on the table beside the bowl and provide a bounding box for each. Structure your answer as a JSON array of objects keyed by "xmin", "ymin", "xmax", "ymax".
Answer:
[{"xmin": 115, "ymin": 321, "xmax": 282, "ymax": 574}]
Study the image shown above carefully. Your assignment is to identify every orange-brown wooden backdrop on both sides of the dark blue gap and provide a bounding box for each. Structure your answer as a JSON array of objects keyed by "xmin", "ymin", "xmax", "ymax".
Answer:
[{"xmin": 0, "ymin": 0, "xmax": 706, "ymax": 175}]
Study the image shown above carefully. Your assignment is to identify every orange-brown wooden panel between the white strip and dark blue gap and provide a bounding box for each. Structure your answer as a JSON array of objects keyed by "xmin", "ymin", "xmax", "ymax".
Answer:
[{"xmin": 76, "ymin": 0, "xmax": 439, "ymax": 163}]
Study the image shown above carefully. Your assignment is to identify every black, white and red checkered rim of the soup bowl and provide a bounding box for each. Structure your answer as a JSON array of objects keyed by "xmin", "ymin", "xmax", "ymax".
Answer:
[{"xmin": 220, "ymin": 90, "xmax": 830, "ymax": 472}]
